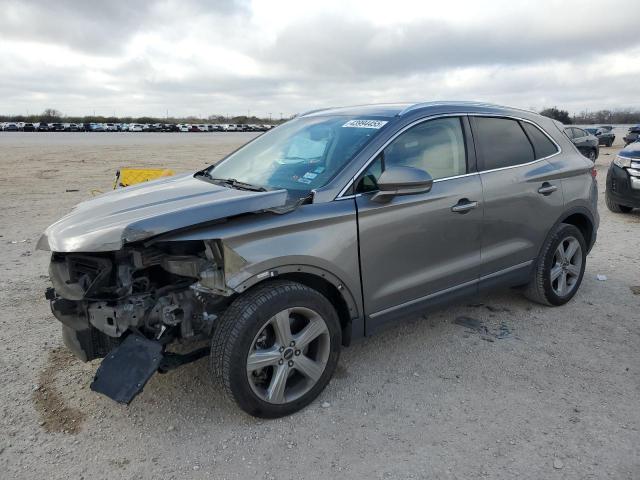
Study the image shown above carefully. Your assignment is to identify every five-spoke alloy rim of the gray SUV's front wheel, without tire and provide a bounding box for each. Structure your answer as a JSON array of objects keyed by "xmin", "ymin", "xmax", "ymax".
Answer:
[{"xmin": 247, "ymin": 307, "xmax": 331, "ymax": 404}]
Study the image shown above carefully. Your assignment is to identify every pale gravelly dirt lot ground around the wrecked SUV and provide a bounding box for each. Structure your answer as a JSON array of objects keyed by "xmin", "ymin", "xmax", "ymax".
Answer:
[{"xmin": 0, "ymin": 132, "xmax": 640, "ymax": 479}]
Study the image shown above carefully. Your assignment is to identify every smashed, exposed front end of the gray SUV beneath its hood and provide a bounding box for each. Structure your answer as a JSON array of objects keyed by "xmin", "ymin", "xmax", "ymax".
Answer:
[{"xmin": 46, "ymin": 240, "xmax": 252, "ymax": 403}]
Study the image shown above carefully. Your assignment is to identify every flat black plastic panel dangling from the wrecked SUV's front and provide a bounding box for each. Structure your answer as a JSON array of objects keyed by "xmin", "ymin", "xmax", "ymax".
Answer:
[{"xmin": 91, "ymin": 335, "xmax": 163, "ymax": 404}]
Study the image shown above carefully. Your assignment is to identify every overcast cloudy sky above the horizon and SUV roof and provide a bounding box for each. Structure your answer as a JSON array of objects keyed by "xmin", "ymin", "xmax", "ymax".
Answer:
[{"xmin": 0, "ymin": 0, "xmax": 640, "ymax": 118}]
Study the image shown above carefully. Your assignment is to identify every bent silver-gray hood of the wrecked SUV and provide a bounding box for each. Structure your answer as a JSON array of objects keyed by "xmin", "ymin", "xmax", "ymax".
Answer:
[{"xmin": 38, "ymin": 174, "xmax": 287, "ymax": 252}]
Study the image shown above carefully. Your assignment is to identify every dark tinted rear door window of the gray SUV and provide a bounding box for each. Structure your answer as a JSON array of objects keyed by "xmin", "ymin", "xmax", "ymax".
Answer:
[{"xmin": 474, "ymin": 117, "xmax": 535, "ymax": 170}]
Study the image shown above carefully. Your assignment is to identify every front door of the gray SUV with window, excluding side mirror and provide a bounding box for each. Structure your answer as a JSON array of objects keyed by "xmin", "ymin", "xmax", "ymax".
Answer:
[{"xmin": 356, "ymin": 117, "xmax": 483, "ymax": 334}]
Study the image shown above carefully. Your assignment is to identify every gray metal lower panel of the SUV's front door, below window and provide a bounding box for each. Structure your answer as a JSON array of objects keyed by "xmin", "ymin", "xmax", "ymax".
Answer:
[{"xmin": 357, "ymin": 175, "xmax": 482, "ymax": 327}]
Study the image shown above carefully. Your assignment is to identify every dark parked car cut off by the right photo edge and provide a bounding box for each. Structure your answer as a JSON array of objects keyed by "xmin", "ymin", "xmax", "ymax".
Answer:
[{"xmin": 605, "ymin": 142, "xmax": 640, "ymax": 213}]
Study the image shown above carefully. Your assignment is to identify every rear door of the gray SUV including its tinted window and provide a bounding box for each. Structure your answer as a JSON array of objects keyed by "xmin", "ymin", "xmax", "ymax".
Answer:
[{"xmin": 470, "ymin": 116, "xmax": 564, "ymax": 286}]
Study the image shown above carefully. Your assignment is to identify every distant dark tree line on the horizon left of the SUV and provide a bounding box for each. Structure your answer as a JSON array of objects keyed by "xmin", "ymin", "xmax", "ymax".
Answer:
[{"xmin": 0, "ymin": 108, "xmax": 284, "ymax": 125}]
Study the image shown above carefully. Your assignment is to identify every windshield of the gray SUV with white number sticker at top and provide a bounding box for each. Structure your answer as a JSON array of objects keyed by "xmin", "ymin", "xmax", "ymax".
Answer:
[{"xmin": 206, "ymin": 116, "xmax": 389, "ymax": 199}]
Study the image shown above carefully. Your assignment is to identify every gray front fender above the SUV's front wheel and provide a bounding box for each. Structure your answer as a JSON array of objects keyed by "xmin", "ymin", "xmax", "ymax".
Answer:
[{"xmin": 158, "ymin": 200, "xmax": 364, "ymax": 335}]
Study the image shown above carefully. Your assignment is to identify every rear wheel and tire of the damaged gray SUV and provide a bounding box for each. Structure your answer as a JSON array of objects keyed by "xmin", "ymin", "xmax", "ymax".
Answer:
[{"xmin": 524, "ymin": 223, "xmax": 587, "ymax": 306}]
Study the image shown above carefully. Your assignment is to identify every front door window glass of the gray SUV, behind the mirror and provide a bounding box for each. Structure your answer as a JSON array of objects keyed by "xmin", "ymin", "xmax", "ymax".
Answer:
[{"xmin": 356, "ymin": 117, "xmax": 467, "ymax": 193}]
